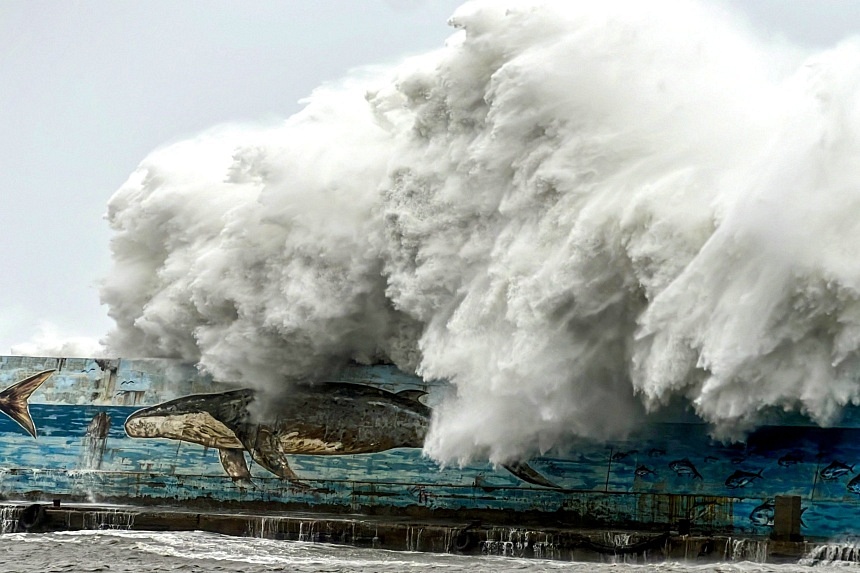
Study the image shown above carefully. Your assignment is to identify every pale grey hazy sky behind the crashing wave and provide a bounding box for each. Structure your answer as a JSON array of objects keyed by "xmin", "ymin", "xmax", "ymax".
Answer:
[{"xmin": 0, "ymin": 0, "xmax": 860, "ymax": 354}]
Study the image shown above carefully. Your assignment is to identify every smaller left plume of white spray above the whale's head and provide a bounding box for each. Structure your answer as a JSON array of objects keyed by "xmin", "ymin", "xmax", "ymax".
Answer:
[{"xmin": 102, "ymin": 77, "xmax": 424, "ymax": 398}]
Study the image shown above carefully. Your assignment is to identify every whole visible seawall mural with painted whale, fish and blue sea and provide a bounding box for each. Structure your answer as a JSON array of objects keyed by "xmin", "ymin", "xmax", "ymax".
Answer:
[{"xmin": 0, "ymin": 356, "xmax": 860, "ymax": 537}]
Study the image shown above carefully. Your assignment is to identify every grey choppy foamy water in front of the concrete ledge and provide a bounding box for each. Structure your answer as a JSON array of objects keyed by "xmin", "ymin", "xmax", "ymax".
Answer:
[{"xmin": 0, "ymin": 530, "xmax": 857, "ymax": 573}]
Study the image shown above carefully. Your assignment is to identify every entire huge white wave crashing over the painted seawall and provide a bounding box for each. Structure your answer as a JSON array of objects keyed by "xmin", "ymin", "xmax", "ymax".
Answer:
[{"xmin": 101, "ymin": 0, "xmax": 860, "ymax": 463}]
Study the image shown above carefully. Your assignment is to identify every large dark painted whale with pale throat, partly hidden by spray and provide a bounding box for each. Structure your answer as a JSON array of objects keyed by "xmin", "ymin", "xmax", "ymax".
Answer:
[{"xmin": 125, "ymin": 382, "xmax": 559, "ymax": 488}]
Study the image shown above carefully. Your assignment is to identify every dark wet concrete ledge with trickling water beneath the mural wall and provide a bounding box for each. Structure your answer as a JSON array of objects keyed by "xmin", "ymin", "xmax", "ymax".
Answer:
[{"xmin": 0, "ymin": 502, "xmax": 828, "ymax": 563}]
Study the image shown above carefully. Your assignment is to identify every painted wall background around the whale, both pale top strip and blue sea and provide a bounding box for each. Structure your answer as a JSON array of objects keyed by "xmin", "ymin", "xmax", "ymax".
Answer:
[{"xmin": 0, "ymin": 357, "xmax": 860, "ymax": 537}]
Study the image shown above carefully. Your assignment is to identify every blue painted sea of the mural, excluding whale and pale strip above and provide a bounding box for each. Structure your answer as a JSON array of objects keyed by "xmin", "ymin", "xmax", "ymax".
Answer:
[{"xmin": 0, "ymin": 398, "xmax": 860, "ymax": 536}]
